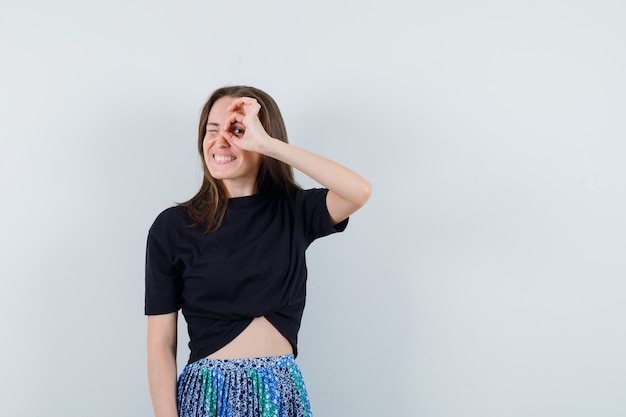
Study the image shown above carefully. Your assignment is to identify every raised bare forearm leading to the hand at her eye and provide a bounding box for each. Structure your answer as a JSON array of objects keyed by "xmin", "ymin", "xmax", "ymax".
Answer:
[{"xmin": 262, "ymin": 139, "xmax": 371, "ymax": 208}]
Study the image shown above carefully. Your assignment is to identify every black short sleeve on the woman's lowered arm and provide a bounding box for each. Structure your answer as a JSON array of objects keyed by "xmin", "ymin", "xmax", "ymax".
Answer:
[{"xmin": 145, "ymin": 210, "xmax": 182, "ymax": 315}]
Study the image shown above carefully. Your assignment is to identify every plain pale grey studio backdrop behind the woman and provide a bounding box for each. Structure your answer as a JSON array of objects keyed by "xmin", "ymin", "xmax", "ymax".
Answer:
[{"xmin": 0, "ymin": 0, "xmax": 626, "ymax": 417}]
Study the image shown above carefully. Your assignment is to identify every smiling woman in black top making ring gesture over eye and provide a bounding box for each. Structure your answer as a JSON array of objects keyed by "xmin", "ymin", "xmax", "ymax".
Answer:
[{"xmin": 145, "ymin": 86, "xmax": 371, "ymax": 417}]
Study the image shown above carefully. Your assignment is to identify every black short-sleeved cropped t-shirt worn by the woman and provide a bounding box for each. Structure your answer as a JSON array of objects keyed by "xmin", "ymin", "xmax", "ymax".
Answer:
[{"xmin": 145, "ymin": 189, "xmax": 348, "ymax": 363}]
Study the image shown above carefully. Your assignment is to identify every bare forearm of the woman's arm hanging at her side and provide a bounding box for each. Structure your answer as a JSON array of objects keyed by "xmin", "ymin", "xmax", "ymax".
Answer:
[{"xmin": 148, "ymin": 344, "xmax": 178, "ymax": 417}]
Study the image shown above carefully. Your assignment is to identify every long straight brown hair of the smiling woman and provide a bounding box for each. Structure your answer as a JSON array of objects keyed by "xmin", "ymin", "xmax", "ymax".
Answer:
[{"xmin": 179, "ymin": 86, "xmax": 300, "ymax": 233}]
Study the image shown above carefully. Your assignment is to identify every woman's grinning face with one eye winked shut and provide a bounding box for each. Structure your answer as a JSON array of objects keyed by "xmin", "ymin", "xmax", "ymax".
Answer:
[{"xmin": 202, "ymin": 97, "xmax": 261, "ymax": 197}]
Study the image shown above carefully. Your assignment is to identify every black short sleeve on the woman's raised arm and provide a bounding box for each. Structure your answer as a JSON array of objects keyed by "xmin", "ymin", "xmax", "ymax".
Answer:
[{"xmin": 296, "ymin": 188, "xmax": 349, "ymax": 244}]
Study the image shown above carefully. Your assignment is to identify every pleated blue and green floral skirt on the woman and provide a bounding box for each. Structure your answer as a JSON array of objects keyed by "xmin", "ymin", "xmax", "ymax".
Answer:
[{"xmin": 178, "ymin": 355, "xmax": 311, "ymax": 417}]
